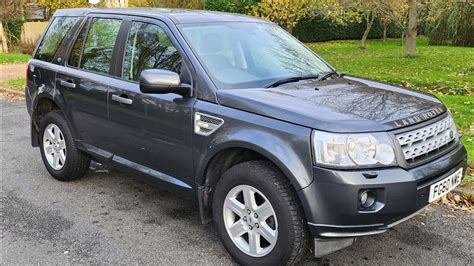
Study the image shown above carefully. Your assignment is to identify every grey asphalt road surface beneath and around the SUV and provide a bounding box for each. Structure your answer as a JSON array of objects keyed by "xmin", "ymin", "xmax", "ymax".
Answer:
[{"xmin": 0, "ymin": 99, "xmax": 474, "ymax": 265}]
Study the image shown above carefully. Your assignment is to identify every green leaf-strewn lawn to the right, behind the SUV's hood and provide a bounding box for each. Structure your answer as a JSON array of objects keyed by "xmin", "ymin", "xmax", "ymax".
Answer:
[{"xmin": 308, "ymin": 37, "xmax": 474, "ymax": 182}]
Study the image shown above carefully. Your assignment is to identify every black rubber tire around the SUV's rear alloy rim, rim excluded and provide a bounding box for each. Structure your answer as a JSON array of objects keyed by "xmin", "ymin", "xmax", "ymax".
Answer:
[{"xmin": 39, "ymin": 110, "xmax": 91, "ymax": 181}]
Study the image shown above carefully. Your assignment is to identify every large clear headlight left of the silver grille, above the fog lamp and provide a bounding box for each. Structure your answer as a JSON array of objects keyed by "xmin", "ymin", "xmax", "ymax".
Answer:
[{"xmin": 312, "ymin": 130, "xmax": 397, "ymax": 168}]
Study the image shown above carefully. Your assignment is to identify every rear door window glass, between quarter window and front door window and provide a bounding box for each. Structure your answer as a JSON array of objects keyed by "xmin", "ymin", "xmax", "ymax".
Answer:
[{"xmin": 80, "ymin": 18, "xmax": 121, "ymax": 74}]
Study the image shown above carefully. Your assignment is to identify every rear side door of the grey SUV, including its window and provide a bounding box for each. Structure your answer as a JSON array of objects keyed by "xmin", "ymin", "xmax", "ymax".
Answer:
[{"xmin": 56, "ymin": 16, "xmax": 122, "ymax": 154}]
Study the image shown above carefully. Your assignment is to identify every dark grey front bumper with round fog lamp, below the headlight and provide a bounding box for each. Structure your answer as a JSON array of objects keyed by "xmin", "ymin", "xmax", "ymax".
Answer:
[{"xmin": 298, "ymin": 144, "xmax": 467, "ymax": 238}]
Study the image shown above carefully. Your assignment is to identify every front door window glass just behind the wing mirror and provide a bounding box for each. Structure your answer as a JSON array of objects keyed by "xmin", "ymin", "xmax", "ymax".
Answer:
[{"xmin": 122, "ymin": 22, "xmax": 182, "ymax": 81}]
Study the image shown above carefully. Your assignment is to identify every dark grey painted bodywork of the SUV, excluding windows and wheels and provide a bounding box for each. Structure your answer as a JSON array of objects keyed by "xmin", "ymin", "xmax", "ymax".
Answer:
[{"xmin": 25, "ymin": 9, "xmax": 466, "ymax": 243}]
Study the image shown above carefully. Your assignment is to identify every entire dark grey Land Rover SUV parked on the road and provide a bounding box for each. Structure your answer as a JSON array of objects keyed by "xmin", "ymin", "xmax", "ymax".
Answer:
[{"xmin": 25, "ymin": 9, "xmax": 466, "ymax": 264}]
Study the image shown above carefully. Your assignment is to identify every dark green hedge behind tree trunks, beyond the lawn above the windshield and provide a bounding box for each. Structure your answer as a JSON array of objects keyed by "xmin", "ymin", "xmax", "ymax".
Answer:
[{"xmin": 293, "ymin": 18, "xmax": 401, "ymax": 42}]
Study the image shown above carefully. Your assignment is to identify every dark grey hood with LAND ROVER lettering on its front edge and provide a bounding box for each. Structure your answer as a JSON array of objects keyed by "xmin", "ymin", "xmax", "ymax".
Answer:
[{"xmin": 217, "ymin": 76, "xmax": 446, "ymax": 132}]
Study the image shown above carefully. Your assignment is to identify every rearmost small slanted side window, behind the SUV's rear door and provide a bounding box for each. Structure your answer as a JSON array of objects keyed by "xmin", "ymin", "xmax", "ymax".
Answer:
[{"xmin": 35, "ymin": 17, "xmax": 79, "ymax": 62}]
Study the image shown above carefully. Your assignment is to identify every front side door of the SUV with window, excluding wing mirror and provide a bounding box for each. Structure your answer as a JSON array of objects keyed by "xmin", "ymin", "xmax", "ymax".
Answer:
[{"xmin": 108, "ymin": 18, "xmax": 195, "ymax": 186}]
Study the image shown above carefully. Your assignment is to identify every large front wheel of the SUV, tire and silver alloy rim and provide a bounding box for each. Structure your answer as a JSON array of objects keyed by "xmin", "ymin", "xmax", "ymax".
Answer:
[{"xmin": 212, "ymin": 161, "xmax": 308, "ymax": 265}]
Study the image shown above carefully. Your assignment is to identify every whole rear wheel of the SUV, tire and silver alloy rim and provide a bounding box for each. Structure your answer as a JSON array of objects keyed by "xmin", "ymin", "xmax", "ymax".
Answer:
[{"xmin": 39, "ymin": 110, "xmax": 91, "ymax": 181}]
